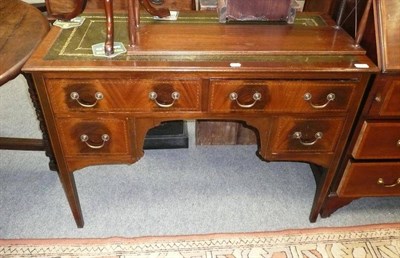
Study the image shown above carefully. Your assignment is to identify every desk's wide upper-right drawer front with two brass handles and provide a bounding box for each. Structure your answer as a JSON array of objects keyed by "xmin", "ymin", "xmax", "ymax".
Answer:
[{"xmin": 210, "ymin": 80, "xmax": 355, "ymax": 112}]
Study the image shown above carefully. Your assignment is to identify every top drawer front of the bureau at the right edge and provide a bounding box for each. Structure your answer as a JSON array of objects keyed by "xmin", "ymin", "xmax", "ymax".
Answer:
[{"xmin": 369, "ymin": 75, "xmax": 400, "ymax": 117}]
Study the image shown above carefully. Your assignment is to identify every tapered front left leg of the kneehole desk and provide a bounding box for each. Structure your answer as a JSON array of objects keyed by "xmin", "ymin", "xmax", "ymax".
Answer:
[{"xmin": 58, "ymin": 171, "xmax": 84, "ymax": 228}]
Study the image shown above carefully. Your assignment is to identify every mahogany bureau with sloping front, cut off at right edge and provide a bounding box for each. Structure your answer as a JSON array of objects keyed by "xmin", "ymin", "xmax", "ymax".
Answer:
[{"xmin": 321, "ymin": 0, "xmax": 400, "ymax": 217}]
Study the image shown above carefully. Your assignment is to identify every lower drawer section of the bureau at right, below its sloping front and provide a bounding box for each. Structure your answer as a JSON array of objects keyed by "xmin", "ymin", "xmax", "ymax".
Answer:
[{"xmin": 322, "ymin": 74, "xmax": 400, "ymax": 217}]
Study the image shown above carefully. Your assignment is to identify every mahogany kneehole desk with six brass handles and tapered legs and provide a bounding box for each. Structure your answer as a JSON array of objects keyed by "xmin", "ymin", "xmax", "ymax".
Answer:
[{"xmin": 24, "ymin": 12, "xmax": 378, "ymax": 227}]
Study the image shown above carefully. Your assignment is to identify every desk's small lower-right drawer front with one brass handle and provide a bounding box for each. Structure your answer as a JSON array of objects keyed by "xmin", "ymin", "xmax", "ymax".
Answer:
[{"xmin": 272, "ymin": 117, "xmax": 344, "ymax": 153}]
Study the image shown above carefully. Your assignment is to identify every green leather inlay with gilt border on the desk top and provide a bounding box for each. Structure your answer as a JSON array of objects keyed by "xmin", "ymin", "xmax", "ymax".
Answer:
[{"xmin": 45, "ymin": 12, "xmax": 326, "ymax": 61}]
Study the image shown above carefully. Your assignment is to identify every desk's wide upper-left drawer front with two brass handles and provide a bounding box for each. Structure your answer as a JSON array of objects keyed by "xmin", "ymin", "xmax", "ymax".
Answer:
[{"xmin": 46, "ymin": 79, "xmax": 201, "ymax": 113}]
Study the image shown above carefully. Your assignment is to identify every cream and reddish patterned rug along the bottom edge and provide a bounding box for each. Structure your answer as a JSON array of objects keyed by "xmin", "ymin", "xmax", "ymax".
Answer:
[{"xmin": 0, "ymin": 223, "xmax": 400, "ymax": 258}]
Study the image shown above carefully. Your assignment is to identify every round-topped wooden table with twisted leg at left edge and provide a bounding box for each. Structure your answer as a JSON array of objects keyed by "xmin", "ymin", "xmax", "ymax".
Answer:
[{"xmin": 0, "ymin": 0, "xmax": 49, "ymax": 150}]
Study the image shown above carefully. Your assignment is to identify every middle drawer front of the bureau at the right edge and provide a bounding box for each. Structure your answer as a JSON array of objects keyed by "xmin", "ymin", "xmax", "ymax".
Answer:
[{"xmin": 352, "ymin": 121, "xmax": 400, "ymax": 159}]
